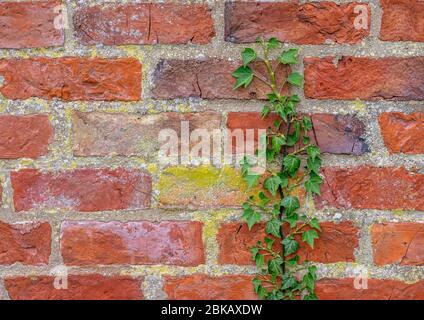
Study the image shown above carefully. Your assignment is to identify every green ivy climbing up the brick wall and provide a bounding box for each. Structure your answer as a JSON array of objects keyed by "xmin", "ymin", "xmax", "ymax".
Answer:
[{"xmin": 233, "ymin": 38, "xmax": 323, "ymax": 300}]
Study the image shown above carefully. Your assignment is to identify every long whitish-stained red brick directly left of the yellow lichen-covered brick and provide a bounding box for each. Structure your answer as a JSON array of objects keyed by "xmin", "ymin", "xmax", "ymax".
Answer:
[{"xmin": 11, "ymin": 168, "xmax": 152, "ymax": 212}]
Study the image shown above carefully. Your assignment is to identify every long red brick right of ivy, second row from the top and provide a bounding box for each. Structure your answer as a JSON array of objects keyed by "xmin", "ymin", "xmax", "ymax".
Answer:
[{"xmin": 305, "ymin": 57, "xmax": 424, "ymax": 100}]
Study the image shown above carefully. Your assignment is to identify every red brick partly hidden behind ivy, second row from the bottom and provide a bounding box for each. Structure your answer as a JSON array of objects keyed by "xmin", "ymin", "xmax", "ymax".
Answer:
[{"xmin": 217, "ymin": 222, "xmax": 359, "ymax": 265}]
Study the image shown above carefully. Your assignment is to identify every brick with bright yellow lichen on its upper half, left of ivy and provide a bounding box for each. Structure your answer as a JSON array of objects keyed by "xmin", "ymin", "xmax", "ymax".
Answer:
[{"xmin": 158, "ymin": 166, "xmax": 252, "ymax": 208}]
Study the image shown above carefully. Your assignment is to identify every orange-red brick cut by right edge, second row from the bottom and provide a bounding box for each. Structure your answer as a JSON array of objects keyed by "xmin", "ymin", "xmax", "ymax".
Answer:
[{"xmin": 371, "ymin": 222, "xmax": 424, "ymax": 266}]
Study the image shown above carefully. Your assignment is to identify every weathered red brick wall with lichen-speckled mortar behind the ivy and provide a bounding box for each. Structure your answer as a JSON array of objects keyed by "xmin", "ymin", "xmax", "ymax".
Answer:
[{"xmin": 0, "ymin": 0, "xmax": 424, "ymax": 299}]
